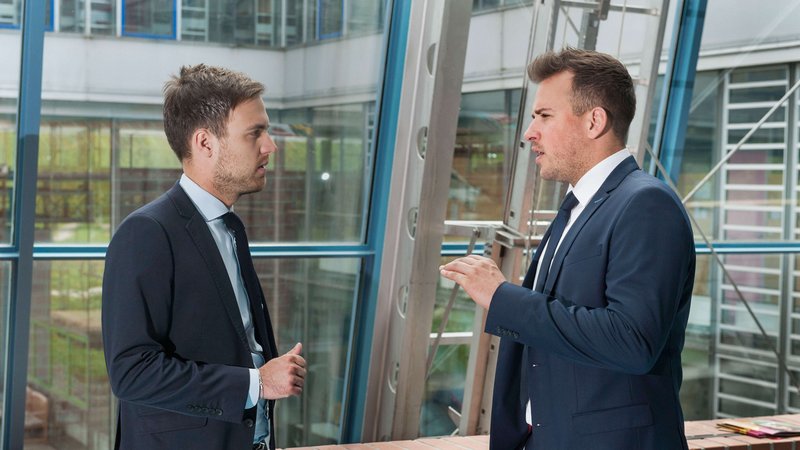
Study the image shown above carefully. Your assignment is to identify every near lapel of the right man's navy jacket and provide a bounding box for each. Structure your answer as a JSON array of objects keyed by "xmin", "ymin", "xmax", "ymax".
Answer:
[{"xmin": 544, "ymin": 156, "xmax": 639, "ymax": 292}]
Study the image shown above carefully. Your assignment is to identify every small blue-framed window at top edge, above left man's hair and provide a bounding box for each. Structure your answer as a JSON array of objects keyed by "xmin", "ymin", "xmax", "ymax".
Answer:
[{"xmin": 122, "ymin": 0, "xmax": 175, "ymax": 38}]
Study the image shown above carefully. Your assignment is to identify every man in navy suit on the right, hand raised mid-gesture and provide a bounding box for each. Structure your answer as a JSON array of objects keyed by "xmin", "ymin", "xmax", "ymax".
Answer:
[{"xmin": 441, "ymin": 48, "xmax": 695, "ymax": 450}]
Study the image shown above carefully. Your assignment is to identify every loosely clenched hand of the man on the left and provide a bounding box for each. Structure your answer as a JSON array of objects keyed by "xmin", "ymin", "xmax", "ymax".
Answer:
[{"xmin": 258, "ymin": 342, "xmax": 306, "ymax": 400}]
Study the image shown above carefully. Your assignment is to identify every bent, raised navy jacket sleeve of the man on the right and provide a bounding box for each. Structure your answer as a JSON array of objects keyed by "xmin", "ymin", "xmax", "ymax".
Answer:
[{"xmin": 485, "ymin": 185, "xmax": 694, "ymax": 374}]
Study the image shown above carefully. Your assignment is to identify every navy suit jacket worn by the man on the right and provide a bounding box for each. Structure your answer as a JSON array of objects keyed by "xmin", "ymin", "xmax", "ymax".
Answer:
[{"xmin": 486, "ymin": 157, "xmax": 695, "ymax": 450}]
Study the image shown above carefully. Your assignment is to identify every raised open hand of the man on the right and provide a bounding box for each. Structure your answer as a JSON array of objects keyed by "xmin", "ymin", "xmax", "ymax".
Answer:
[{"xmin": 439, "ymin": 255, "xmax": 506, "ymax": 309}]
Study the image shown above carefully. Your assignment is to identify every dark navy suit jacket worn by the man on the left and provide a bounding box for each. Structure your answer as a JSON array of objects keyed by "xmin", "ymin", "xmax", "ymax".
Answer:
[{"xmin": 102, "ymin": 184, "xmax": 277, "ymax": 450}]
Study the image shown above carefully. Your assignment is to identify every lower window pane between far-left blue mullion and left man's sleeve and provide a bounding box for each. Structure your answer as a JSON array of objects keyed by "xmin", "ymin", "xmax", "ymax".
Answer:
[{"xmin": 25, "ymin": 261, "xmax": 108, "ymax": 449}]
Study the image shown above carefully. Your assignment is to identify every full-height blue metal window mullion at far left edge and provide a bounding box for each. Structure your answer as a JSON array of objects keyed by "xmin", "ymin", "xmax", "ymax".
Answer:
[{"xmin": 1, "ymin": 1, "xmax": 45, "ymax": 448}]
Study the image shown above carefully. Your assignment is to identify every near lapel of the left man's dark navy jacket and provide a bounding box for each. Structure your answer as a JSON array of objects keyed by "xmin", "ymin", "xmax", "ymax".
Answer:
[{"xmin": 167, "ymin": 183, "xmax": 250, "ymax": 348}]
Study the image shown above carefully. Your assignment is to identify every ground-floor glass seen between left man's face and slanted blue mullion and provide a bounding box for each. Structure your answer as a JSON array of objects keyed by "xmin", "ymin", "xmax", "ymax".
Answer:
[{"xmin": 244, "ymin": 103, "xmax": 374, "ymax": 242}]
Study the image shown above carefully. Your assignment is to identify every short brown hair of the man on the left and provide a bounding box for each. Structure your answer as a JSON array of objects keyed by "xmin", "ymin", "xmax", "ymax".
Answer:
[{"xmin": 164, "ymin": 64, "xmax": 264, "ymax": 161}]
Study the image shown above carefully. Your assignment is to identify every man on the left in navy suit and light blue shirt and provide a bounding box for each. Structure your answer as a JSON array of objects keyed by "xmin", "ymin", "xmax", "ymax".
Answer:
[{"xmin": 102, "ymin": 64, "xmax": 306, "ymax": 450}]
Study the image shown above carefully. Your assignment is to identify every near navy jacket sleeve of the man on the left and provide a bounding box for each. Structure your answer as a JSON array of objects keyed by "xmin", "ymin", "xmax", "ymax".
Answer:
[{"xmin": 102, "ymin": 214, "xmax": 249, "ymax": 423}]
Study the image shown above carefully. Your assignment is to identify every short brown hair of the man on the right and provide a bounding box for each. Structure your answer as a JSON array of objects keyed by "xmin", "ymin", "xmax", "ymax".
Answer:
[{"xmin": 528, "ymin": 47, "xmax": 636, "ymax": 142}]
